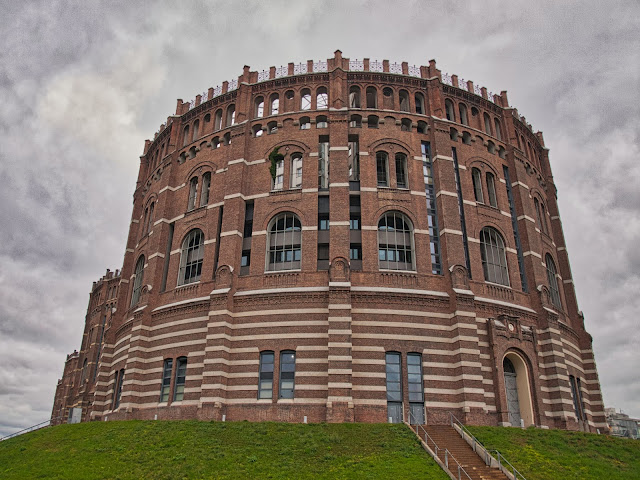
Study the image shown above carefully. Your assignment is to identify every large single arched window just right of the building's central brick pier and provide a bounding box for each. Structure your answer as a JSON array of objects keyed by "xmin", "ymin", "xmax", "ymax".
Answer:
[{"xmin": 378, "ymin": 211, "xmax": 415, "ymax": 270}]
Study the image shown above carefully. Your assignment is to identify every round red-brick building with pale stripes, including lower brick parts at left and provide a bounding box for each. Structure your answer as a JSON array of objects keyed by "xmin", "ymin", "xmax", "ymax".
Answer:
[{"xmin": 54, "ymin": 51, "xmax": 604, "ymax": 431}]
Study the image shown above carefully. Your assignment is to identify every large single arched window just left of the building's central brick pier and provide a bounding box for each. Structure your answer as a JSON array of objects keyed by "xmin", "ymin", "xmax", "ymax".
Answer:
[{"xmin": 267, "ymin": 212, "xmax": 302, "ymax": 271}]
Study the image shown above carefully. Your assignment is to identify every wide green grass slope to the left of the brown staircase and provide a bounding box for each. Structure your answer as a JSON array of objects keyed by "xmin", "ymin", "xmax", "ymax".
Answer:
[{"xmin": 0, "ymin": 421, "xmax": 448, "ymax": 480}]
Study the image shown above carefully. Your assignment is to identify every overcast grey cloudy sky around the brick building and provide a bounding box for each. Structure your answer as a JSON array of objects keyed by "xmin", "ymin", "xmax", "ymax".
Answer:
[{"xmin": 0, "ymin": 0, "xmax": 640, "ymax": 436}]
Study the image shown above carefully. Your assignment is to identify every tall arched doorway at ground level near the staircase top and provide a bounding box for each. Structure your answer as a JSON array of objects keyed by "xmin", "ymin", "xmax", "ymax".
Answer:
[{"xmin": 502, "ymin": 352, "xmax": 535, "ymax": 427}]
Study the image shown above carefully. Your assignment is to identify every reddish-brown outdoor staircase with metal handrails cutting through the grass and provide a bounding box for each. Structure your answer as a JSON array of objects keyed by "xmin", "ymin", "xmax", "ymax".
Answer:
[{"xmin": 422, "ymin": 425, "xmax": 508, "ymax": 480}]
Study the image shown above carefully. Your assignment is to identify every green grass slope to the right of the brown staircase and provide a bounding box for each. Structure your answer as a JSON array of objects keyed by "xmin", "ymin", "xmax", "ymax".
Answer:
[{"xmin": 468, "ymin": 427, "xmax": 640, "ymax": 480}]
